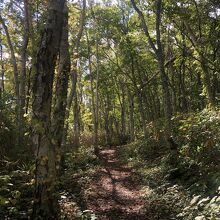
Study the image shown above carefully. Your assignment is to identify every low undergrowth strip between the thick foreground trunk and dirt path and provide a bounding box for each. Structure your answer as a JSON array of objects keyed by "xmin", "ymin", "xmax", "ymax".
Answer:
[{"xmin": 60, "ymin": 146, "xmax": 100, "ymax": 220}]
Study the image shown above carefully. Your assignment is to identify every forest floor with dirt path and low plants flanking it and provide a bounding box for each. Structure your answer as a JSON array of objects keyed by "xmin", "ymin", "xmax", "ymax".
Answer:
[{"xmin": 60, "ymin": 144, "xmax": 220, "ymax": 220}]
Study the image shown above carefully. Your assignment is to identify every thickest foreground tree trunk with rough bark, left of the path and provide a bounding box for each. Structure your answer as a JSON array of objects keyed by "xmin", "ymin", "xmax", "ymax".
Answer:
[{"xmin": 32, "ymin": 0, "xmax": 65, "ymax": 219}]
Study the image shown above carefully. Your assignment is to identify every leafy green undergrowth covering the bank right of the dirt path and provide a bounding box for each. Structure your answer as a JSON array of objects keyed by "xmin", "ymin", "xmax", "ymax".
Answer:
[{"xmin": 119, "ymin": 109, "xmax": 220, "ymax": 220}]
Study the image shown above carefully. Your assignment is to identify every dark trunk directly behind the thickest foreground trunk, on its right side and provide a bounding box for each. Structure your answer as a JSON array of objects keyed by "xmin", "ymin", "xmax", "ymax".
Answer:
[{"xmin": 51, "ymin": 4, "xmax": 70, "ymax": 172}]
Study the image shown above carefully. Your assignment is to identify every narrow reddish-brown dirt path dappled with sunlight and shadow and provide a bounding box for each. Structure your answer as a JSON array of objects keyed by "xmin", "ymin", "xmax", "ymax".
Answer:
[{"xmin": 87, "ymin": 148, "xmax": 147, "ymax": 220}]
